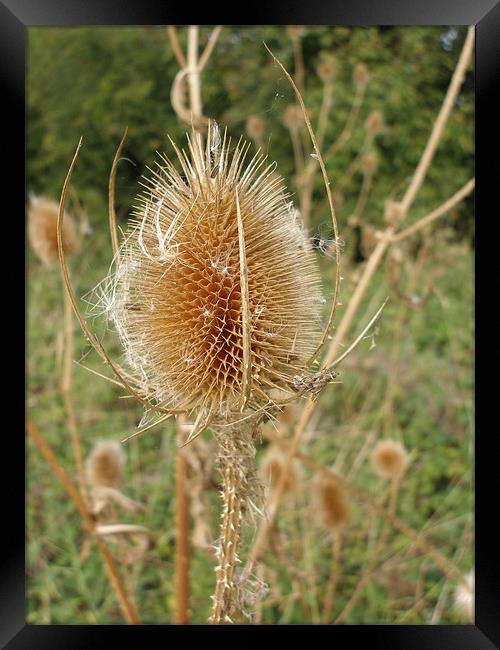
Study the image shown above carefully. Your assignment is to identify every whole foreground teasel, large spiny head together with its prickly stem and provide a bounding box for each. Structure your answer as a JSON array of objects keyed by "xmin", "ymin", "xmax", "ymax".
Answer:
[{"xmin": 27, "ymin": 25, "xmax": 472, "ymax": 622}]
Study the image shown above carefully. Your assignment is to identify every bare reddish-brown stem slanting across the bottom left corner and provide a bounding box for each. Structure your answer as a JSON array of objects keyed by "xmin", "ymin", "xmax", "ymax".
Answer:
[{"xmin": 27, "ymin": 417, "xmax": 140, "ymax": 625}]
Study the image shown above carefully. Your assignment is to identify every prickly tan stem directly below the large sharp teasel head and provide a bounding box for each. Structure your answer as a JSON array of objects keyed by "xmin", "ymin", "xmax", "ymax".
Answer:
[{"xmin": 209, "ymin": 428, "xmax": 258, "ymax": 625}]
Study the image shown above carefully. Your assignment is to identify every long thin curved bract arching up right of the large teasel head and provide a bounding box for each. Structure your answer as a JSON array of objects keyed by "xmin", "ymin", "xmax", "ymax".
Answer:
[{"xmin": 264, "ymin": 43, "xmax": 341, "ymax": 365}]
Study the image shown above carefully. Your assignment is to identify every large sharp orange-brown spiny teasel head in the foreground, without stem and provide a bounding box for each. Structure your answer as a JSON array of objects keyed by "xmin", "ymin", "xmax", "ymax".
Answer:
[{"xmin": 106, "ymin": 123, "xmax": 323, "ymax": 422}]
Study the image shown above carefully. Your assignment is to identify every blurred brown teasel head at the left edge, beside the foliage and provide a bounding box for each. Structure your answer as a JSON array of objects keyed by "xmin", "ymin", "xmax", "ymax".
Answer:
[{"xmin": 28, "ymin": 195, "xmax": 79, "ymax": 266}]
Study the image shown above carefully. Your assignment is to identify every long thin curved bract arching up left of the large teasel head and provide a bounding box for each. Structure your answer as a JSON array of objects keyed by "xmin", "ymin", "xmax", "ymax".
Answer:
[{"xmin": 57, "ymin": 137, "xmax": 175, "ymax": 413}]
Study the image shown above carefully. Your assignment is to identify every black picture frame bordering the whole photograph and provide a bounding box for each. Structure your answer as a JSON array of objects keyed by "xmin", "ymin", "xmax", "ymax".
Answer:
[{"xmin": 9, "ymin": 0, "xmax": 500, "ymax": 650}]
